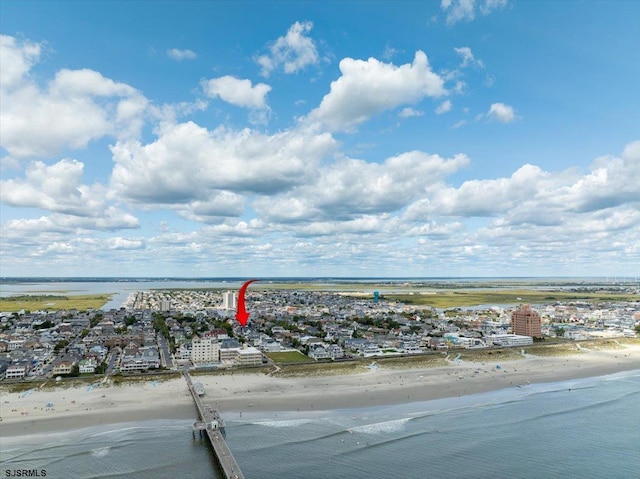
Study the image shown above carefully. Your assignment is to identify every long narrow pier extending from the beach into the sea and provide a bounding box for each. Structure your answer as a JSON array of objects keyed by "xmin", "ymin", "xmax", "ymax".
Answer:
[{"xmin": 184, "ymin": 371, "xmax": 244, "ymax": 479}]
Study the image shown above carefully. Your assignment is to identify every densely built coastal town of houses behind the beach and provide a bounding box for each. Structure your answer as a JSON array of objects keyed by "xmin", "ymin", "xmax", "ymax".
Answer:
[{"xmin": 0, "ymin": 289, "xmax": 640, "ymax": 380}]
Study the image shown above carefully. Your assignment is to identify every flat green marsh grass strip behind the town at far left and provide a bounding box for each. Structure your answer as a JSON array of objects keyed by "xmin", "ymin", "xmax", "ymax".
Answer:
[{"xmin": 0, "ymin": 294, "xmax": 111, "ymax": 313}]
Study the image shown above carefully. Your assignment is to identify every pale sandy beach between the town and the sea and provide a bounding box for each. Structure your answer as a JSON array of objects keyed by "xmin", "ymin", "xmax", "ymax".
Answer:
[{"xmin": 0, "ymin": 344, "xmax": 640, "ymax": 437}]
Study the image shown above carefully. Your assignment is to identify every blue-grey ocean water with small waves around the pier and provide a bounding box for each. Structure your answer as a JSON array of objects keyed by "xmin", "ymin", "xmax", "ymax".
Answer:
[{"xmin": 0, "ymin": 370, "xmax": 640, "ymax": 479}]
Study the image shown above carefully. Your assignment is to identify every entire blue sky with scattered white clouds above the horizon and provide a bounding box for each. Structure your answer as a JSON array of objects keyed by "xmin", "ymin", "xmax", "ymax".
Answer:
[{"xmin": 0, "ymin": 0, "xmax": 640, "ymax": 278}]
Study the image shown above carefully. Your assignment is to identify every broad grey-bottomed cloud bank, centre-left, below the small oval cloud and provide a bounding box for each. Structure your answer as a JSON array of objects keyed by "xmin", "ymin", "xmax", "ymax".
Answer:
[{"xmin": 111, "ymin": 122, "xmax": 335, "ymax": 204}]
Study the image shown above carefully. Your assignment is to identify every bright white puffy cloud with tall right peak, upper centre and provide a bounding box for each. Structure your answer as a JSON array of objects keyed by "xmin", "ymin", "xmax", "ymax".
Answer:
[{"xmin": 309, "ymin": 51, "xmax": 446, "ymax": 130}]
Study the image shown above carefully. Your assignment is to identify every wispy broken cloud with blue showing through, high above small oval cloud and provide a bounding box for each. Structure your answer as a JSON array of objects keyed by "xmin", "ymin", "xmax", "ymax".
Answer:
[{"xmin": 256, "ymin": 22, "xmax": 319, "ymax": 77}]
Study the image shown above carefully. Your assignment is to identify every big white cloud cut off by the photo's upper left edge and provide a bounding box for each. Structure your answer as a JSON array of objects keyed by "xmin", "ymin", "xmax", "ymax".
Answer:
[{"xmin": 0, "ymin": 37, "xmax": 147, "ymax": 159}]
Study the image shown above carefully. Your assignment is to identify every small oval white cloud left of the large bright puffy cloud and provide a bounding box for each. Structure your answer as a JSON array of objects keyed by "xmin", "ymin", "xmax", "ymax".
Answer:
[{"xmin": 202, "ymin": 75, "xmax": 271, "ymax": 109}]
